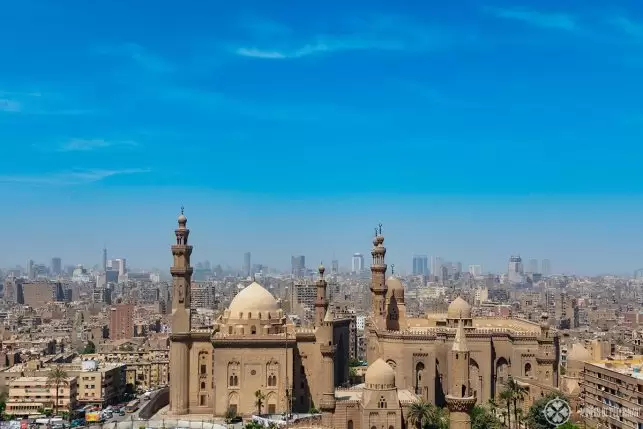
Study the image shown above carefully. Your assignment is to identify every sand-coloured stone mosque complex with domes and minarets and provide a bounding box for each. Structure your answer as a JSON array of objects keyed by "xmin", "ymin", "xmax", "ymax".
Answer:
[{"xmin": 170, "ymin": 212, "xmax": 559, "ymax": 429}]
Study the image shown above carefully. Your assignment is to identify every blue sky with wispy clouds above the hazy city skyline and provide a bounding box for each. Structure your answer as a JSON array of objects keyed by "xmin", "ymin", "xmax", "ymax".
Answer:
[{"xmin": 0, "ymin": 0, "xmax": 643, "ymax": 273}]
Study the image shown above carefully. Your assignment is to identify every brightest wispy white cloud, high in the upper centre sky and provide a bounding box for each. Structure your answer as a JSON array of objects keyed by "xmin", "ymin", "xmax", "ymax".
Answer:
[{"xmin": 232, "ymin": 17, "xmax": 456, "ymax": 60}]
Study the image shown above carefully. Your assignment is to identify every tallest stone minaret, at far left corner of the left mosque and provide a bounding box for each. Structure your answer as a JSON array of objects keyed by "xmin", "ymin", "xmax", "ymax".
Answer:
[{"xmin": 170, "ymin": 207, "xmax": 192, "ymax": 415}]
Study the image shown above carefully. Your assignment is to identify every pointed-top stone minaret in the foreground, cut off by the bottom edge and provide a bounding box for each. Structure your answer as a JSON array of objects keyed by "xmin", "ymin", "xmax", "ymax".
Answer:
[{"xmin": 446, "ymin": 319, "xmax": 476, "ymax": 429}]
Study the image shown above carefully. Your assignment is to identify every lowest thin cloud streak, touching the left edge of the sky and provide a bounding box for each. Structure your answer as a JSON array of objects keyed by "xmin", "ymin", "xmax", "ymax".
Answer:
[{"xmin": 0, "ymin": 168, "xmax": 150, "ymax": 185}]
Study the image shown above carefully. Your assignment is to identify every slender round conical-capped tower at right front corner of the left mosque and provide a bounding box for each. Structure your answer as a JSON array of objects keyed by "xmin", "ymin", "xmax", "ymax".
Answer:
[{"xmin": 317, "ymin": 310, "xmax": 337, "ymax": 427}]
